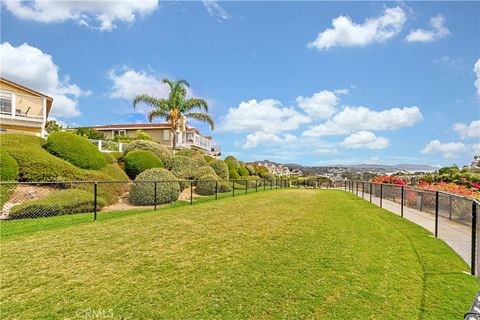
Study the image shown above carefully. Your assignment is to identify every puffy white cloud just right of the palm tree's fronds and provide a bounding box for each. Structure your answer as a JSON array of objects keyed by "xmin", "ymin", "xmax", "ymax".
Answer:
[{"xmin": 220, "ymin": 99, "xmax": 310, "ymax": 133}]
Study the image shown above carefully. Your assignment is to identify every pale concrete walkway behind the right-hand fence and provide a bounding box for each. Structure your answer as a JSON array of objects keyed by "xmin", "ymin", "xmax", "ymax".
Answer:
[{"xmin": 341, "ymin": 189, "xmax": 474, "ymax": 274}]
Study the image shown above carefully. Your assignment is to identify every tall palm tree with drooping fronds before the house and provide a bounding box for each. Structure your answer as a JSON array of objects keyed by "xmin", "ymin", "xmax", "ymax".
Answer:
[{"xmin": 133, "ymin": 79, "xmax": 214, "ymax": 150}]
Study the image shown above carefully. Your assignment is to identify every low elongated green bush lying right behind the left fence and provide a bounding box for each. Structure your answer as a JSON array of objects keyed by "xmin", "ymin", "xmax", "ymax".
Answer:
[{"xmin": 9, "ymin": 189, "xmax": 106, "ymax": 219}]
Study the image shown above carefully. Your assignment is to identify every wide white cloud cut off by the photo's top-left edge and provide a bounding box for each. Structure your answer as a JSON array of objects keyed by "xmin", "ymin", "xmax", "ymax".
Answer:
[{"xmin": 3, "ymin": 0, "xmax": 158, "ymax": 31}]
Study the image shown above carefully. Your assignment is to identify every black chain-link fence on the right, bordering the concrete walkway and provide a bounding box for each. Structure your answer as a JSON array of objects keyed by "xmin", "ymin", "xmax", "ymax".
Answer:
[{"xmin": 344, "ymin": 180, "xmax": 480, "ymax": 275}]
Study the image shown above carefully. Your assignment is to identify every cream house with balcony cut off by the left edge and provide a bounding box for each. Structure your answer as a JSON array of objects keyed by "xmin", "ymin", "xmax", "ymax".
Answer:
[{"xmin": 0, "ymin": 77, "xmax": 53, "ymax": 137}]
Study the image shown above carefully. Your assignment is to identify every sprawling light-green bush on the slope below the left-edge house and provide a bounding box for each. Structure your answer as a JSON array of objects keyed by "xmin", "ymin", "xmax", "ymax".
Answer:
[{"xmin": 0, "ymin": 133, "xmax": 86, "ymax": 181}]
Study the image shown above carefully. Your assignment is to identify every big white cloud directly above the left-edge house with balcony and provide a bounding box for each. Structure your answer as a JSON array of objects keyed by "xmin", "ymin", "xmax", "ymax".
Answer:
[{"xmin": 0, "ymin": 42, "xmax": 90, "ymax": 117}]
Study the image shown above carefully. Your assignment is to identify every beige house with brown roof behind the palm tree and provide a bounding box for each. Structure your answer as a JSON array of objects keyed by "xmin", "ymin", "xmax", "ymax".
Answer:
[{"xmin": 90, "ymin": 123, "xmax": 219, "ymax": 154}]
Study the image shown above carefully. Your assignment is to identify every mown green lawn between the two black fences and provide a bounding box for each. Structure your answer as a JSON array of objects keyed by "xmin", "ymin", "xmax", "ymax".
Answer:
[{"xmin": 0, "ymin": 189, "xmax": 479, "ymax": 319}]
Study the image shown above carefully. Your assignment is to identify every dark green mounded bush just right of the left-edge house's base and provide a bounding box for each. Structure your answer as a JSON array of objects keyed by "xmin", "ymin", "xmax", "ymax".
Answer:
[{"xmin": 45, "ymin": 132, "xmax": 107, "ymax": 170}]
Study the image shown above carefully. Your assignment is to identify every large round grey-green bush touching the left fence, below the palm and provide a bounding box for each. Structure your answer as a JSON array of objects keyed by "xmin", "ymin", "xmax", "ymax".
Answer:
[{"xmin": 128, "ymin": 168, "xmax": 180, "ymax": 206}]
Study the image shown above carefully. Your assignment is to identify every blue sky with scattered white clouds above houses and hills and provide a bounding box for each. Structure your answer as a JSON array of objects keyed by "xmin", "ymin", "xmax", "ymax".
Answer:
[{"xmin": 0, "ymin": 1, "xmax": 480, "ymax": 165}]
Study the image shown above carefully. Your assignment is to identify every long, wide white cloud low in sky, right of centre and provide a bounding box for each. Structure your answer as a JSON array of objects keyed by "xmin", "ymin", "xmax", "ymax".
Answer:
[{"xmin": 303, "ymin": 106, "xmax": 423, "ymax": 137}]
